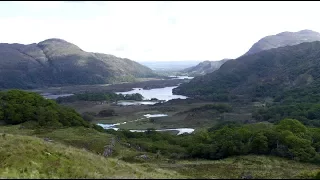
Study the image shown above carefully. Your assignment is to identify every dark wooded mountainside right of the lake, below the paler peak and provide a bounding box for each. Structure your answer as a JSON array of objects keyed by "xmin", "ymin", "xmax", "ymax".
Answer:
[{"xmin": 173, "ymin": 41, "xmax": 320, "ymax": 100}]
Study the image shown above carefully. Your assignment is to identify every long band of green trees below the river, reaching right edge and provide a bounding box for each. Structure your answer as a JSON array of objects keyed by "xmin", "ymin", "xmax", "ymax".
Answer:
[{"xmin": 105, "ymin": 119, "xmax": 320, "ymax": 163}]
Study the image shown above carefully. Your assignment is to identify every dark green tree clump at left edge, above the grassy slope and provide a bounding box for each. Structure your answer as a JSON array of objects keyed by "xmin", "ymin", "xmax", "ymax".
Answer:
[{"xmin": 0, "ymin": 90, "xmax": 89, "ymax": 127}]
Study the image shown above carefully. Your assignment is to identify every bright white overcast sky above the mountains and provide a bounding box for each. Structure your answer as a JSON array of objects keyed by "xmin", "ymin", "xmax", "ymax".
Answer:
[{"xmin": 0, "ymin": 1, "xmax": 320, "ymax": 62}]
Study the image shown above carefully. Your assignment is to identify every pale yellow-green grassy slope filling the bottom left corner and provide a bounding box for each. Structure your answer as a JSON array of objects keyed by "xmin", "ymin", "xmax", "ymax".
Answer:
[{"xmin": 0, "ymin": 134, "xmax": 183, "ymax": 178}]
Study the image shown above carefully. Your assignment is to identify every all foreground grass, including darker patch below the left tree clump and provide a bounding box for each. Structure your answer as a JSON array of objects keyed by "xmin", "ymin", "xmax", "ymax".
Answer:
[{"xmin": 0, "ymin": 123, "xmax": 320, "ymax": 179}]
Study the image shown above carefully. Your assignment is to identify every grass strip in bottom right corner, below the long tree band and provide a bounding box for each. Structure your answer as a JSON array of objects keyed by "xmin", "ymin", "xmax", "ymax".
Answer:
[{"xmin": 161, "ymin": 155, "xmax": 320, "ymax": 179}]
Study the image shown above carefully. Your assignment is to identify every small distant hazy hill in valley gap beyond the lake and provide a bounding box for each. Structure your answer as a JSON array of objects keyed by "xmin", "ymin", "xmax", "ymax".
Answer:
[{"xmin": 180, "ymin": 59, "xmax": 230, "ymax": 76}]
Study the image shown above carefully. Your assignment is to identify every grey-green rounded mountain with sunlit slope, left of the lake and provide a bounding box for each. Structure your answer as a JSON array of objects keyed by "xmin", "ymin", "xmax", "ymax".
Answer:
[{"xmin": 0, "ymin": 39, "xmax": 155, "ymax": 89}]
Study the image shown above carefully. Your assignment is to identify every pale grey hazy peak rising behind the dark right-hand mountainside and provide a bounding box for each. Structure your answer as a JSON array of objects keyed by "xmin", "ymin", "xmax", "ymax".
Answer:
[{"xmin": 245, "ymin": 30, "xmax": 320, "ymax": 55}]
